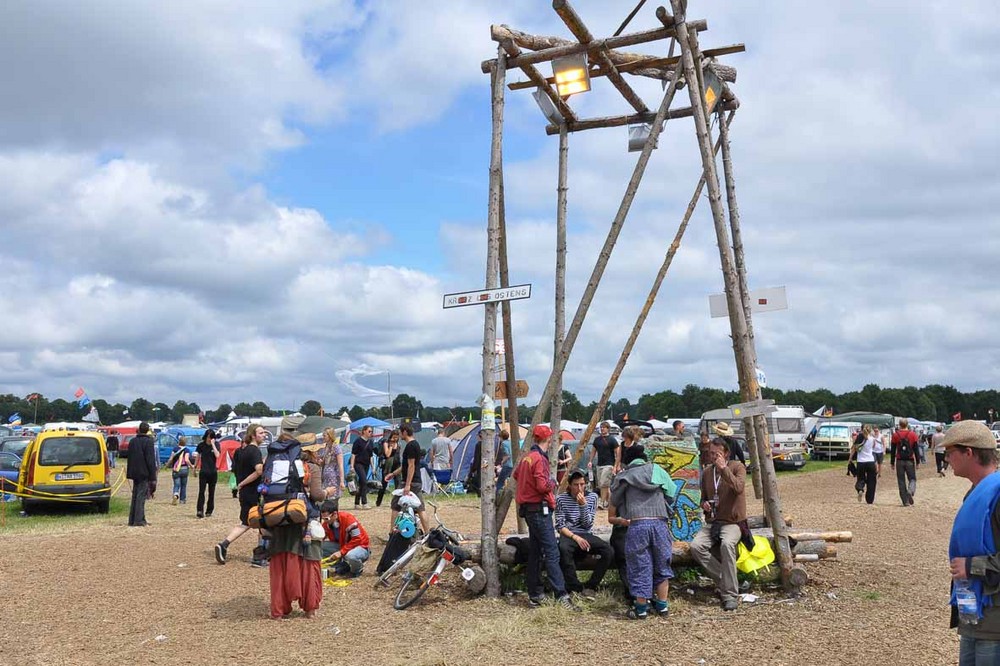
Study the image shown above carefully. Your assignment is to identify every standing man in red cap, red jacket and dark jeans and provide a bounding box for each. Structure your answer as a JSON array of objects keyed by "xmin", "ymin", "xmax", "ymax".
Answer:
[{"xmin": 514, "ymin": 425, "xmax": 572, "ymax": 608}]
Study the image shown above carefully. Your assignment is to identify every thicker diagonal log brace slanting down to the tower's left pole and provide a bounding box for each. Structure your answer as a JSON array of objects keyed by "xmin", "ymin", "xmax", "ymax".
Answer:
[{"xmin": 497, "ymin": 70, "xmax": 677, "ymax": 525}]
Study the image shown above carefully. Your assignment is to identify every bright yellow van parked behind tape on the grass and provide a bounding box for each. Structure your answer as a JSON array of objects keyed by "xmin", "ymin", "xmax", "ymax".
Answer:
[{"xmin": 18, "ymin": 430, "xmax": 111, "ymax": 514}]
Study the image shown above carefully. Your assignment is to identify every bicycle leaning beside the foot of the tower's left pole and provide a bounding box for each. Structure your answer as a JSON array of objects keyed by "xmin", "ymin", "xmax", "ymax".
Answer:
[{"xmin": 375, "ymin": 501, "xmax": 485, "ymax": 610}]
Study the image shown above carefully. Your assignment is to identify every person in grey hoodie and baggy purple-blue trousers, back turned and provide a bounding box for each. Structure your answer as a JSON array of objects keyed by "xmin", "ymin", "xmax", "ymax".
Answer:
[{"xmin": 609, "ymin": 452, "xmax": 677, "ymax": 620}]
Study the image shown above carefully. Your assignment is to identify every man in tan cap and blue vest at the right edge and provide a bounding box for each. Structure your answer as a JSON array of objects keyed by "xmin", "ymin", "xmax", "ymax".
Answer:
[{"xmin": 943, "ymin": 421, "xmax": 1000, "ymax": 664}]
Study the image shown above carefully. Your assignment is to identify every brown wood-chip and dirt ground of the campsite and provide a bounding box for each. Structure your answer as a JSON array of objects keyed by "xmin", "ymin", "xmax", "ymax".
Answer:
[{"xmin": 0, "ymin": 465, "xmax": 968, "ymax": 666}]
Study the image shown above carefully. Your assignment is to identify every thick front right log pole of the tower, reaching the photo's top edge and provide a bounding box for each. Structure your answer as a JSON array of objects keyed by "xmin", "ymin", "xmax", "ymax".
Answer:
[{"xmin": 670, "ymin": 0, "xmax": 808, "ymax": 591}]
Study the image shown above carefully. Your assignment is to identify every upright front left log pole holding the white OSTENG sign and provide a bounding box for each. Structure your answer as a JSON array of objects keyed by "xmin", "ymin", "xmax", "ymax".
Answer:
[{"xmin": 477, "ymin": 47, "xmax": 507, "ymax": 598}]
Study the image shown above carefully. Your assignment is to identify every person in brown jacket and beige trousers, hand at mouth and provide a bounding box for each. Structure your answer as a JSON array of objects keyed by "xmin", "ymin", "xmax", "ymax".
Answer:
[{"xmin": 692, "ymin": 437, "xmax": 747, "ymax": 611}]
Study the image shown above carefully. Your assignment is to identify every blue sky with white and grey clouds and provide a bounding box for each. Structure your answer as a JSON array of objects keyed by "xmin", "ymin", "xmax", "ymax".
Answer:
[{"xmin": 0, "ymin": 0, "xmax": 1000, "ymax": 416}]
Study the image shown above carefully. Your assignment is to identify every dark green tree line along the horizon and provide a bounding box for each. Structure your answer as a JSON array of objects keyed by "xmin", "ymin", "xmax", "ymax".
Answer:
[{"xmin": 0, "ymin": 384, "xmax": 1000, "ymax": 423}]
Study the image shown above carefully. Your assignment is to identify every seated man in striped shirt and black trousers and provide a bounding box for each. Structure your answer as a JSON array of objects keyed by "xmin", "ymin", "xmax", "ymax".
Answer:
[{"xmin": 556, "ymin": 470, "xmax": 614, "ymax": 596}]
